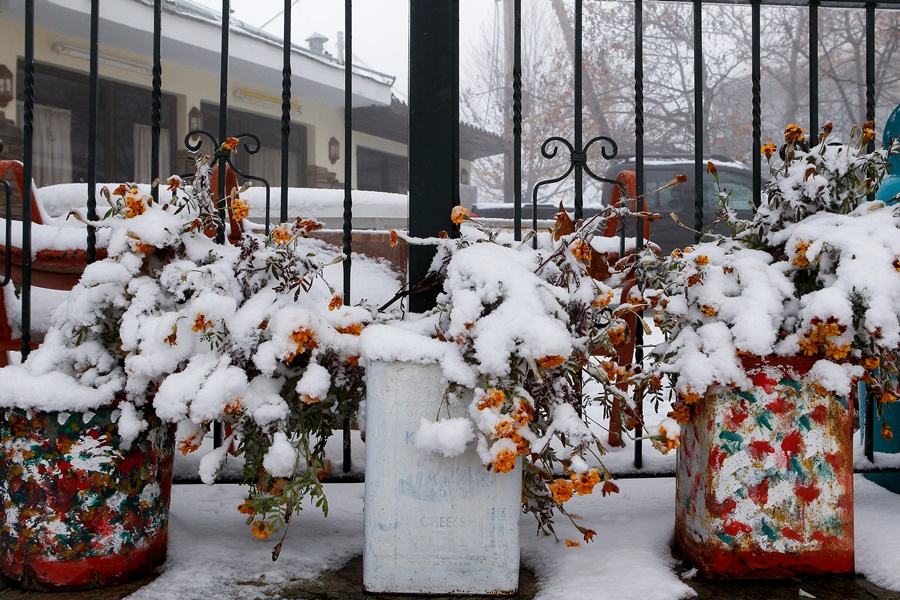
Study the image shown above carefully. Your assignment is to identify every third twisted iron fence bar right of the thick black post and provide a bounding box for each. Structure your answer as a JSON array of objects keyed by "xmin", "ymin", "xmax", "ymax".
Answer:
[{"xmin": 632, "ymin": 0, "xmax": 644, "ymax": 469}]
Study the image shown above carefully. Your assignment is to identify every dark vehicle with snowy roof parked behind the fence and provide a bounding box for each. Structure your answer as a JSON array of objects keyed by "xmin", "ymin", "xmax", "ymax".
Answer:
[{"xmin": 472, "ymin": 154, "xmax": 754, "ymax": 253}]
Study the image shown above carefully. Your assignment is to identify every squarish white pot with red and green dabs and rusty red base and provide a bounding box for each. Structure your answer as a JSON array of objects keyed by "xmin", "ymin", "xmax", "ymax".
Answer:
[{"xmin": 675, "ymin": 357, "xmax": 854, "ymax": 578}]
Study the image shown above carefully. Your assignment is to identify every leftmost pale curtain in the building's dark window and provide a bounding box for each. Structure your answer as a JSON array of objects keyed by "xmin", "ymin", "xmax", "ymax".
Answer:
[{"xmin": 33, "ymin": 105, "xmax": 72, "ymax": 186}]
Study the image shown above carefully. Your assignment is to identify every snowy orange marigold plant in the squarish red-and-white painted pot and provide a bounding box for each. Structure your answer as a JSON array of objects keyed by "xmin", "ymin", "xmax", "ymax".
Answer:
[{"xmin": 640, "ymin": 122, "xmax": 900, "ymax": 434}]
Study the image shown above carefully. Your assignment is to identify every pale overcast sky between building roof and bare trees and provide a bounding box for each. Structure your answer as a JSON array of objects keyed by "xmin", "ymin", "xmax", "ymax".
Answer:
[{"xmin": 194, "ymin": 0, "xmax": 497, "ymax": 97}]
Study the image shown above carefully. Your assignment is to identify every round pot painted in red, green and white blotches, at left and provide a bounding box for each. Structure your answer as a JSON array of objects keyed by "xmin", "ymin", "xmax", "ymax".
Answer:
[{"xmin": 0, "ymin": 407, "xmax": 174, "ymax": 590}]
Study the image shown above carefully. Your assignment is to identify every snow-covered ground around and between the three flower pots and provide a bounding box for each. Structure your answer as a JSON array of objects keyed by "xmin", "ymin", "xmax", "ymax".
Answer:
[{"xmin": 123, "ymin": 476, "xmax": 900, "ymax": 600}]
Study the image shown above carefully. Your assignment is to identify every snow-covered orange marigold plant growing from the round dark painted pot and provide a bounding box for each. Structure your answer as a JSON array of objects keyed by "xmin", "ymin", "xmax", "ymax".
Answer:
[{"xmin": 4, "ymin": 158, "xmax": 371, "ymax": 556}]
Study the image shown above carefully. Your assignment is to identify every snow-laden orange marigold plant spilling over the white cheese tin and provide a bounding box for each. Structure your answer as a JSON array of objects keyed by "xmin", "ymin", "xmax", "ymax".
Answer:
[{"xmin": 380, "ymin": 207, "xmax": 645, "ymax": 545}]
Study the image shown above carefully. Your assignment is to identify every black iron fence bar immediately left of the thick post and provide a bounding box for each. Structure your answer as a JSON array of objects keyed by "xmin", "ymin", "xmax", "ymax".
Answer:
[{"xmin": 342, "ymin": 0, "xmax": 353, "ymax": 473}]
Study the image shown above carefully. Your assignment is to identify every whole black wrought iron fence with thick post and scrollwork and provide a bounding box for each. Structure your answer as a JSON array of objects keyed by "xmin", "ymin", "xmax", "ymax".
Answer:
[{"xmin": 0, "ymin": 0, "xmax": 900, "ymax": 478}]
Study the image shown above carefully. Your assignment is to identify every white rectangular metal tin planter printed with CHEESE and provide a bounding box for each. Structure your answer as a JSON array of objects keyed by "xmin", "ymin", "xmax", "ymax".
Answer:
[{"xmin": 363, "ymin": 362, "xmax": 522, "ymax": 595}]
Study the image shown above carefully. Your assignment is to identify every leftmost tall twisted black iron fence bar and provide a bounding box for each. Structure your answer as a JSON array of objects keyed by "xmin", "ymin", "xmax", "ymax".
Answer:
[{"xmin": 20, "ymin": 0, "xmax": 34, "ymax": 361}]
